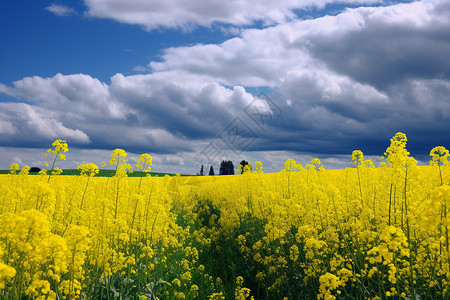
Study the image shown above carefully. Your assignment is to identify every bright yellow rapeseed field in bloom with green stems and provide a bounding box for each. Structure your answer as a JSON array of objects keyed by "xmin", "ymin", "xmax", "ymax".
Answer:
[{"xmin": 0, "ymin": 133, "xmax": 450, "ymax": 300}]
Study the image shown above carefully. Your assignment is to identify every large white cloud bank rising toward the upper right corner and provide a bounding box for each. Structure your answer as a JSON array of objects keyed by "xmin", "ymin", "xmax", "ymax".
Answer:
[{"xmin": 149, "ymin": 2, "xmax": 450, "ymax": 92}]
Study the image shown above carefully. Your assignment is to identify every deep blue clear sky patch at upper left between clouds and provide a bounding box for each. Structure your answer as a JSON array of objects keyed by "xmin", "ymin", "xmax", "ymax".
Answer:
[{"xmin": 0, "ymin": 1, "xmax": 232, "ymax": 84}]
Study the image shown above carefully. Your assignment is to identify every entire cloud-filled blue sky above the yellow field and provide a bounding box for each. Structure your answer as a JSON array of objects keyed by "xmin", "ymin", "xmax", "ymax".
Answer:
[{"xmin": 0, "ymin": 0, "xmax": 450, "ymax": 174}]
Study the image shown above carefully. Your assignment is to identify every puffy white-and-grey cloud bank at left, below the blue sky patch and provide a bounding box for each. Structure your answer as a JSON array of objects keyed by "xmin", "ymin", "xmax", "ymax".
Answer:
[{"xmin": 0, "ymin": 73, "xmax": 253, "ymax": 157}]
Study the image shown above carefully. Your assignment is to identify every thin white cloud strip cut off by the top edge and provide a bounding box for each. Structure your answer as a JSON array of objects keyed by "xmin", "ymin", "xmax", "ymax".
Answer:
[{"xmin": 84, "ymin": 0, "xmax": 382, "ymax": 30}]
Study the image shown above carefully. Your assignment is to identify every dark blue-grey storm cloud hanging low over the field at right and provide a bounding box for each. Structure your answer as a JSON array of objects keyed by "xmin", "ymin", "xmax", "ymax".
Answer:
[{"xmin": 251, "ymin": 79, "xmax": 450, "ymax": 156}]
